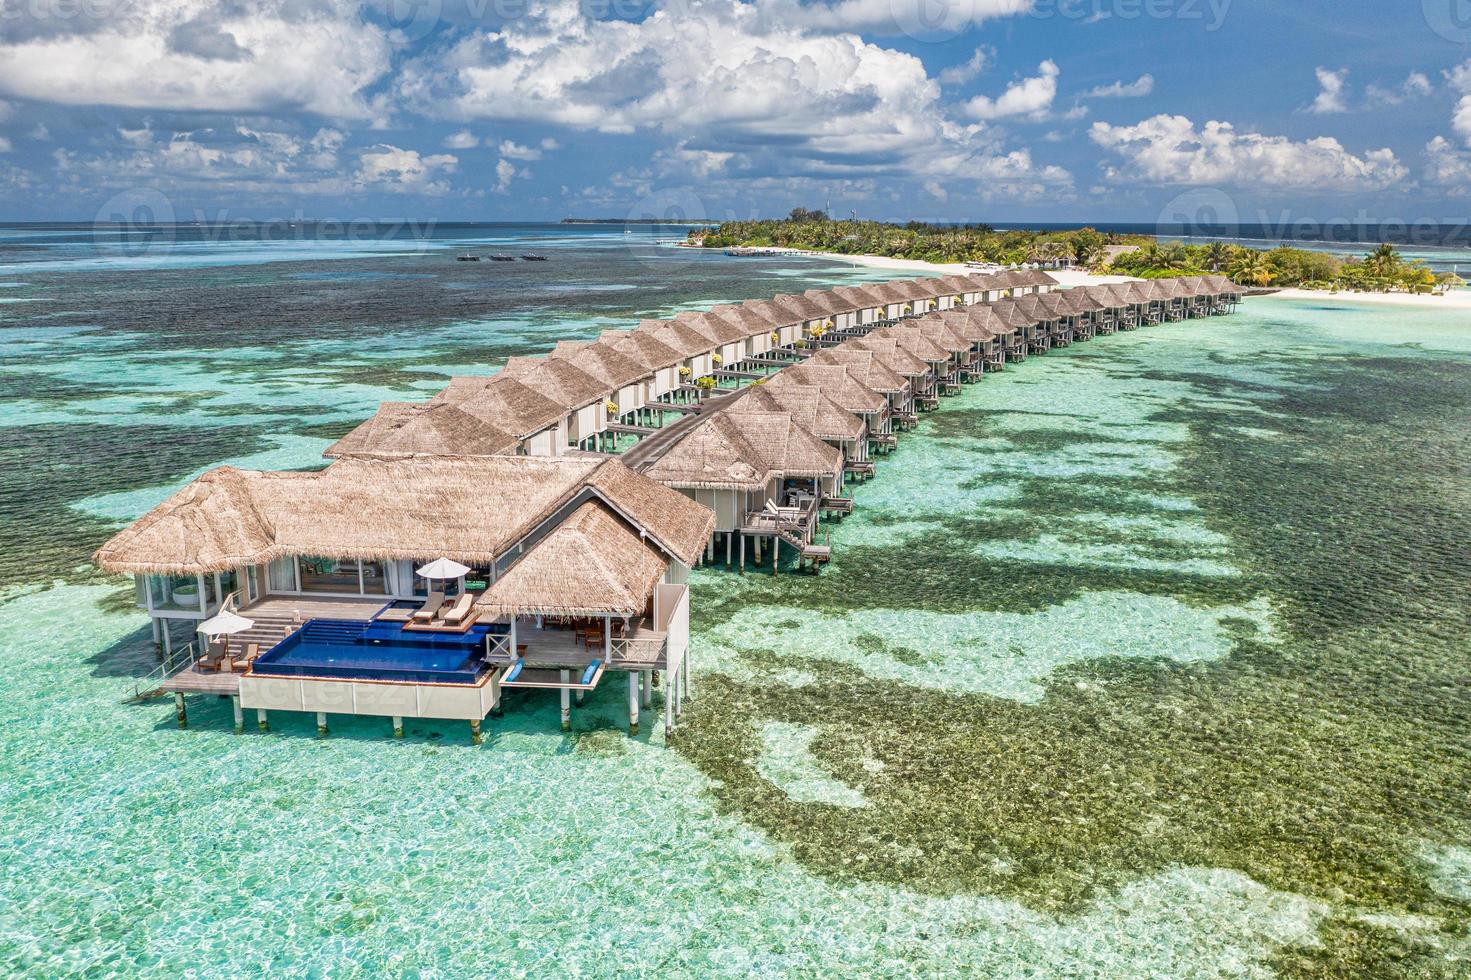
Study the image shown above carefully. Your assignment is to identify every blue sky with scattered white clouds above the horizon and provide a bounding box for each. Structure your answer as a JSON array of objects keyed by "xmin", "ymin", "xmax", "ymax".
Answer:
[{"xmin": 0, "ymin": 0, "xmax": 1471, "ymax": 227}]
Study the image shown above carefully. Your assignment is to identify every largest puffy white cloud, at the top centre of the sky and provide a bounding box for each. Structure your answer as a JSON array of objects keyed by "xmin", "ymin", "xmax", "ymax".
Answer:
[{"xmin": 399, "ymin": 0, "xmax": 1055, "ymax": 192}]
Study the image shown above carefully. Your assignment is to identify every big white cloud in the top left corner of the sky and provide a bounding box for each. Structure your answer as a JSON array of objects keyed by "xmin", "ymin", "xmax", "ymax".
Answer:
[{"xmin": 0, "ymin": 0, "xmax": 391, "ymax": 118}]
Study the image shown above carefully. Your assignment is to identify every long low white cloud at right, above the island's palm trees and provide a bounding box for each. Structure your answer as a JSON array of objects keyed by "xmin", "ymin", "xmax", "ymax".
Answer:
[{"xmin": 1089, "ymin": 115, "xmax": 1408, "ymax": 190}]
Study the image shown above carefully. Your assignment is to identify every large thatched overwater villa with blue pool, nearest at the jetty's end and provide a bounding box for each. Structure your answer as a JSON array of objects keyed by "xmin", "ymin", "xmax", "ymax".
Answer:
[{"xmin": 94, "ymin": 446, "xmax": 711, "ymax": 742}]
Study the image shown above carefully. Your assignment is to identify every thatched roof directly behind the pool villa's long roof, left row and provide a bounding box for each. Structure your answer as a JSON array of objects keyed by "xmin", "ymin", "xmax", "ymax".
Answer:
[{"xmin": 322, "ymin": 402, "xmax": 521, "ymax": 459}]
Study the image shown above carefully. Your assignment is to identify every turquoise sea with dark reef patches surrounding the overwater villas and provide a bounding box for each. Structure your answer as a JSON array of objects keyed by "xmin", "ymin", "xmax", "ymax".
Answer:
[{"xmin": 0, "ymin": 227, "xmax": 1471, "ymax": 977}]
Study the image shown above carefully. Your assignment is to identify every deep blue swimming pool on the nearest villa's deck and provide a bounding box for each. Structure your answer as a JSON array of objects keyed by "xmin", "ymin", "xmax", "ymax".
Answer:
[{"xmin": 252, "ymin": 619, "xmax": 506, "ymax": 684}]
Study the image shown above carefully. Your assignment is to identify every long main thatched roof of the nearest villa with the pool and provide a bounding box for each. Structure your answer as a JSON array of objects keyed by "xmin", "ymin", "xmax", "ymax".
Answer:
[{"xmin": 93, "ymin": 456, "xmax": 715, "ymax": 574}]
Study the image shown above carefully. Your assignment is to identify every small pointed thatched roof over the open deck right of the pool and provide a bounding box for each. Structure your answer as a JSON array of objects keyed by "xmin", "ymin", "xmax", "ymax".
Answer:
[{"xmin": 475, "ymin": 502, "xmax": 669, "ymax": 617}]
